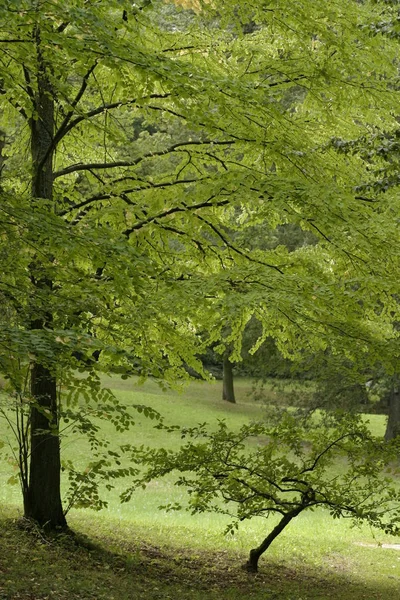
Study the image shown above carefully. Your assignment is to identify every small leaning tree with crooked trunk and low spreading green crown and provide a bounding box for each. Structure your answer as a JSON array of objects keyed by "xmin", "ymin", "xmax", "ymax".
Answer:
[{"xmin": 123, "ymin": 413, "xmax": 400, "ymax": 572}]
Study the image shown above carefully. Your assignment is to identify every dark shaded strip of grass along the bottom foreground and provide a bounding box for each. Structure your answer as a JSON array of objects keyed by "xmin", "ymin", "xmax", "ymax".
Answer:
[{"xmin": 0, "ymin": 510, "xmax": 399, "ymax": 600}]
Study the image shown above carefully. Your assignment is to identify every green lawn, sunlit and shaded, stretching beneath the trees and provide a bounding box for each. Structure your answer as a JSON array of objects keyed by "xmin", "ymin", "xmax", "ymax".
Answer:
[{"xmin": 0, "ymin": 379, "xmax": 400, "ymax": 600}]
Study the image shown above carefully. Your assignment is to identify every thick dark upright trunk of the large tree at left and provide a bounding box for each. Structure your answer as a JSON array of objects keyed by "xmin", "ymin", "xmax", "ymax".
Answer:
[{"xmin": 24, "ymin": 25, "xmax": 66, "ymax": 529}]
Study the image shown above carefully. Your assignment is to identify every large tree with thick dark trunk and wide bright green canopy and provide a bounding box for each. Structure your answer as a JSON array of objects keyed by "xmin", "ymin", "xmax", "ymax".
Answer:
[{"xmin": 0, "ymin": 0, "xmax": 398, "ymax": 527}]
